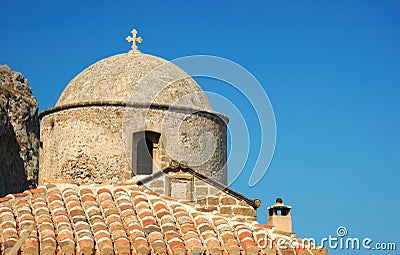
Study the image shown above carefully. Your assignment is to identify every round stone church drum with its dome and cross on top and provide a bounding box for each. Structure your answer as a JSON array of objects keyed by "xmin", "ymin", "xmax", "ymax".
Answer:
[{"xmin": 39, "ymin": 30, "xmax": 228, "ymax": 187}]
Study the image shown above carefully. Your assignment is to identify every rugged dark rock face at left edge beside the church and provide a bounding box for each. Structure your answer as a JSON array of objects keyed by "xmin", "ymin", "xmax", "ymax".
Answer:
[{"xmin": 0, "ymin": 65, "xmax": 39, "ymax": 196}]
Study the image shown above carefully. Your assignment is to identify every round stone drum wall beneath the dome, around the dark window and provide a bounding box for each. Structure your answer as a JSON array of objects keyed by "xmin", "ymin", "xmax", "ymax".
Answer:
[{"xmin": 39, "ymin": 106, "xmax": 227, "ymax": 184}]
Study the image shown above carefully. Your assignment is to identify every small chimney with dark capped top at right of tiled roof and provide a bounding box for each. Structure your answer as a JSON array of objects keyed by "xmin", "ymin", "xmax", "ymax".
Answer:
[{"xmin": 268, "ymin": 198, "xmax": 292, "ymax": 233}]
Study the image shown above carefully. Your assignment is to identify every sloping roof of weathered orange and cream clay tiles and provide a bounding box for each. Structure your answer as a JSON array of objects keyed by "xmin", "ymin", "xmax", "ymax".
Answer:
[{"xmin": 0, "ymin": 185, "xmax": 324, "ymax": 255}]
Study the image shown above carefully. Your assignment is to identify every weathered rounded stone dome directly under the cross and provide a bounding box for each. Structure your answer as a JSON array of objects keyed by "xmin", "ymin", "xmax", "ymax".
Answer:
[{"xmin": 56, "ymin": 51, "xmax": 212, "ymax": 111}]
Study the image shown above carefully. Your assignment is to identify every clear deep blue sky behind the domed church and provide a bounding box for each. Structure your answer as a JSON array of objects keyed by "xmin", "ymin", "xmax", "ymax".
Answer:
[{"xmin": 0, "ymin": 1, "xmax": 400, "ymax": 254}]
